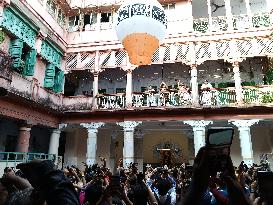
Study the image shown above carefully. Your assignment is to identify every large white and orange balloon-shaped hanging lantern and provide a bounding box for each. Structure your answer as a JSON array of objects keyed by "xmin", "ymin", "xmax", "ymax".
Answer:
[{"xmin": 116, "ymin": 0, "xmax": 167, "ymax": 65}]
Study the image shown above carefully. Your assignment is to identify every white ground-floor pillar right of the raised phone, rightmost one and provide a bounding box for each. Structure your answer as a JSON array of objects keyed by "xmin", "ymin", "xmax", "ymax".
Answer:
[{"xmin": 229, "ymin": 120, "xmax": 259, "ymax": 166}]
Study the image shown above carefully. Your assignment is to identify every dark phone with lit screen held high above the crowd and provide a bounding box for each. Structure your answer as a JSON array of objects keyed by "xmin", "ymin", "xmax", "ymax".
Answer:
[{"xmin": 205, "ymin": 127, "xmax": 234, "ymax": 176}]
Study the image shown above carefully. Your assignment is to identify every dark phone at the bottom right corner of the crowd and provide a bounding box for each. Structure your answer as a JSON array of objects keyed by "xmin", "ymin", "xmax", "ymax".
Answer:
[{"xmin": 257, "ymin": 171, "xmax": 273, "ymax": 204}]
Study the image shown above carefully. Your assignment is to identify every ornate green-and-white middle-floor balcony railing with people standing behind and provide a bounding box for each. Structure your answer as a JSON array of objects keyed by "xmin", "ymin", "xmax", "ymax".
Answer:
[{"xmin": 96, "ymin": 85, "xmax": 273, "ymax": 110}]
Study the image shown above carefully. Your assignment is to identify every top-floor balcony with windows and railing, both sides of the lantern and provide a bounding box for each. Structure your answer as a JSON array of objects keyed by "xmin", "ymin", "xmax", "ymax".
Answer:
[{"xmin": 67, "ymin": 0, "xmax": 272, "ymax": 50}]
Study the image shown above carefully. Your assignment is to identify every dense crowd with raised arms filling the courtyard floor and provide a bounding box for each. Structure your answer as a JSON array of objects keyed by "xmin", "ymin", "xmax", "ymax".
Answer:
[{"xmin": 0, "ymin": 148, "xmax": 273, "ymax": 205}]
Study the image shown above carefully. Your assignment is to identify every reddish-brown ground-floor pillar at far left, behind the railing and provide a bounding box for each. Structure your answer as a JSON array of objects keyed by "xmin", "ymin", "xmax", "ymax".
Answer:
[{"xmin": 16, "ymin": 125, "xmax": 31, "ymax": 152}]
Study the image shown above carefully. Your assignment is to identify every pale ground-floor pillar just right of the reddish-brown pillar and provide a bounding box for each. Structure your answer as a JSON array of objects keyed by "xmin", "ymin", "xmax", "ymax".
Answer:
[{"xmin": 48, "ymin": 124, "xmax": 67, "ymax": 156}]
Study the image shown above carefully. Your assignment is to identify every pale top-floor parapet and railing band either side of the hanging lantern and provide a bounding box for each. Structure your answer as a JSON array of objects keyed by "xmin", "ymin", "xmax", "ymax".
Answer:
[{"xmin": 67, "ymin": 13, "xmax": 272, "ymax": 50}]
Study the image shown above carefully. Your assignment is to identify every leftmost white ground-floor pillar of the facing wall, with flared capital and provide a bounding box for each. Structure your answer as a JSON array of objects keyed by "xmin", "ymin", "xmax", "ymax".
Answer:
[{"xmin": 81, "ymin": 122, "xmax": 104, "ymax": 165}]
